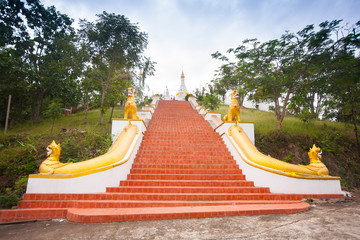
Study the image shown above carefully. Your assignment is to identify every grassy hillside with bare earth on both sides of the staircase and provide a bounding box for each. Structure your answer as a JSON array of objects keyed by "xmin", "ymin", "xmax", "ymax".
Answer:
[{"xmin": 0, "ymin": 106, "xmax": 360, "ymax": 208}]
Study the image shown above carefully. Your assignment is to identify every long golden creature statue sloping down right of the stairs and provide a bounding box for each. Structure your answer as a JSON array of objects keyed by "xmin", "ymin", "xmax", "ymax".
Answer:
[{"xmin": 229, "ymin": 125, "xmax": 338, "ymax": 179}]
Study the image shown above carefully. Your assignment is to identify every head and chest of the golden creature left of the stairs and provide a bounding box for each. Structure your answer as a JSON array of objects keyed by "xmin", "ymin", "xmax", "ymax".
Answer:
[{"xmin": 39, "ymin": 141, "xmax": 70, "ymax": 175}]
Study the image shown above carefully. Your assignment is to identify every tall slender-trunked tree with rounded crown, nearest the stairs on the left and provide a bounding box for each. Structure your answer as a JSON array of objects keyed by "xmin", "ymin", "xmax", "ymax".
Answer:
[{"xmin": 80, "ymin": 12, "xmax": 147, "ymax": 124}]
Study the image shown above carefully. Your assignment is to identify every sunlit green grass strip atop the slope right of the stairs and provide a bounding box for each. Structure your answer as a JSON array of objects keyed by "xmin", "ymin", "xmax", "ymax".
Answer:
[{"xmin": 217, "ymin": 105, "xmax": 354, "ymax": 138}]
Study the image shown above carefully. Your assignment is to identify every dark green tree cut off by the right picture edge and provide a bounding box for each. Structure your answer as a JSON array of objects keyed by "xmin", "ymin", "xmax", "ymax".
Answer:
[{"xmin": 325, "ymin": 21, "xmax": 360, "ymax": 154}]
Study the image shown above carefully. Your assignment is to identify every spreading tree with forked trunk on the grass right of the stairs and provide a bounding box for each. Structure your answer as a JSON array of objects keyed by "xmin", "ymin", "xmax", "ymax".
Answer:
[{"xmin": 212, "ymin": 20, "xmax": 341, "ymax": 130}]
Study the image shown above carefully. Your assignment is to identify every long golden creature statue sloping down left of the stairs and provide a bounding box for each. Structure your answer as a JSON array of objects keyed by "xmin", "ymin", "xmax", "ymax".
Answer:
[{"xmin": 39, "ymin": 125, "xmax": 138, "ymax": 175}]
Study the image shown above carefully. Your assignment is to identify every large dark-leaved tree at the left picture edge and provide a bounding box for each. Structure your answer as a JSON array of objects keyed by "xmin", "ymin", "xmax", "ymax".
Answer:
[{"xmin": 0, "ymin": 0, "xmax": 84, "ymax": 122}]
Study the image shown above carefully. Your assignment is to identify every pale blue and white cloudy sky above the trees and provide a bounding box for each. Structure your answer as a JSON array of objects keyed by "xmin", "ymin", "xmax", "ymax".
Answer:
[{"xmin": 43, "ymin": 0, "xmax": 360, "ymax": 95}]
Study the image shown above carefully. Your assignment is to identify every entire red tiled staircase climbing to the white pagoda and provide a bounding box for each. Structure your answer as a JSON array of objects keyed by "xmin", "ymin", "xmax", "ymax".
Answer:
[{"xmin": 0, "ymin": 101, "xmax": 320, "ymax": 222}]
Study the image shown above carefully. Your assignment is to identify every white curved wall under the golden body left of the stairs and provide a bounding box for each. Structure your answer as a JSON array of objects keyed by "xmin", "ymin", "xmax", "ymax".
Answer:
[{"xmin": 26, "ymin": 132, "xmax": 143, "ymax": 193}]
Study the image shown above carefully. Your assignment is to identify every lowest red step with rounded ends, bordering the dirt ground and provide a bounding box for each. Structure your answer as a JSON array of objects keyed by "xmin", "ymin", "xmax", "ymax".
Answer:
[{"xmin": 67, "ymin": 202, "xmax": 310, "ymax": 223}]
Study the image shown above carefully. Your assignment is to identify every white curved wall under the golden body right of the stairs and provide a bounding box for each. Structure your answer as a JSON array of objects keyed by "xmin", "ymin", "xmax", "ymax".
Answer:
[{"xmin": 222, "ymin": 133, "xmax": 343, "ymax": 194}]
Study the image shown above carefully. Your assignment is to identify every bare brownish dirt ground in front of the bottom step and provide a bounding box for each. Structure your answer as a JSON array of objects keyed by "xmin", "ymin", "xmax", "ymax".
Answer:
[{"xmin": 0, "ymin": 194, "xmax": 360, "ymax": 240}]
